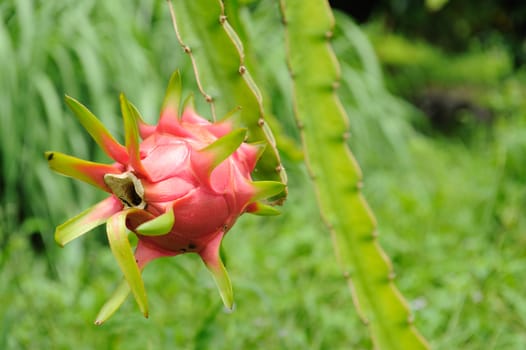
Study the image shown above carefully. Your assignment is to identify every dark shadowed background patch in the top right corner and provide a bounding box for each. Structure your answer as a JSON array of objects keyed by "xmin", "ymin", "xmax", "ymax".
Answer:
[{"xmin": 368, "ymin": 0, "xmax": 526, "ymax": 65}]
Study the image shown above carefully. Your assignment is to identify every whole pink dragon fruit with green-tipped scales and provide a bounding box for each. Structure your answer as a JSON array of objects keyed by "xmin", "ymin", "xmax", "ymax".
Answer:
[{"xmin": 46, "ymin": 72, "xmax": 285, "ymax": 324}]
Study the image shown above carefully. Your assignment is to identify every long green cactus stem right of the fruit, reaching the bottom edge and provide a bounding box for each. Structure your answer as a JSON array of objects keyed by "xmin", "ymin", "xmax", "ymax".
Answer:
[{"xmin": 280, "ymin": 0, "xmax": 428, "ymax": 350}]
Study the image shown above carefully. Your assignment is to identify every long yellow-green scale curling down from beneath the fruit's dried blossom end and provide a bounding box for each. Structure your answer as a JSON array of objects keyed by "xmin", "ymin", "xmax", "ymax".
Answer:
[{"xmin": 106, "ymin": 208, "xmax": 148, "ymax": 317}]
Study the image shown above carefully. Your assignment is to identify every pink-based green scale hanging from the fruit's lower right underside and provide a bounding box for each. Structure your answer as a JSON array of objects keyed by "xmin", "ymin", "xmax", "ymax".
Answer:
[{"xmin": 199, "ymin": 232, "xmax": 234, "ymax": 310}]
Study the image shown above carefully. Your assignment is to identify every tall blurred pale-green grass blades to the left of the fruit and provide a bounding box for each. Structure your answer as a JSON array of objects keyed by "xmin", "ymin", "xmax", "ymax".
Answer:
[{"xmin": 0, "ymin": 0, "xmax": 176, "ymax": 253}]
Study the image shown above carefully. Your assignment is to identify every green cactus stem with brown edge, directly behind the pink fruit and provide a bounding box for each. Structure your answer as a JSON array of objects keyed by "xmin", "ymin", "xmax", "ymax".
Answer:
[{"xmin": 167, "ymin": 0, "xmax": 287, "ymax": 197}]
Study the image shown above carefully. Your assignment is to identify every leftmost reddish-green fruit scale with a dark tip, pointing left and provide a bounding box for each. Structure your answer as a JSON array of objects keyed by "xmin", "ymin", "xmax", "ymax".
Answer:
[{"xmin": 44, "ymin": 151, "xmax": 122, "ymax": 193}]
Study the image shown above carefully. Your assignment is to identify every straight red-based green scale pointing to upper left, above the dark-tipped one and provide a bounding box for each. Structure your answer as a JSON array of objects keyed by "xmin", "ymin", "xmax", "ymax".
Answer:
[{"xmin": 64, "ymin": 95, "xmax": 128, "ymax": 164}]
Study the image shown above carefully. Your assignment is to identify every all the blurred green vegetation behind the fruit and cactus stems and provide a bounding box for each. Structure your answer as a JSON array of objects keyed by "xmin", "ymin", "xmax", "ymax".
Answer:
[{"xmin": 0, "ymin": 0, "xmax": 526, "ymax": 349}]
